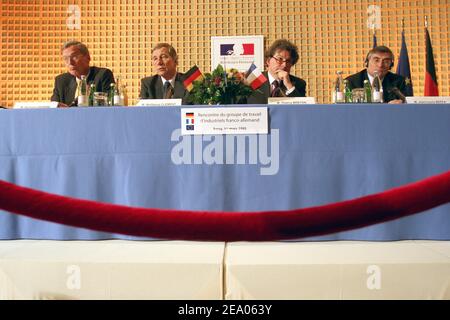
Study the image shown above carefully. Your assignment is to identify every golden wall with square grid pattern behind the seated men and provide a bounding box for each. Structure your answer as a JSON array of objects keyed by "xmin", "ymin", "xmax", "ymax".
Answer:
[{"xmin": 0, "ymin": 0, "xmax": 450, "ymax": 107}]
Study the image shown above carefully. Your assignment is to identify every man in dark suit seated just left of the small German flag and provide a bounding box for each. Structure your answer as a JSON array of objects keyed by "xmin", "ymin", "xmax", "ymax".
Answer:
[{"xmin": 139, "ymin": 43, "xmax": 189, "ymax": 104}]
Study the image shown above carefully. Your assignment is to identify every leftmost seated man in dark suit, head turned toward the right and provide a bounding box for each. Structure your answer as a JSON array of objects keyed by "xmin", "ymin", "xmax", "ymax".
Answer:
[{"xmin": 50, "ymin": 41, "xmax": 114, "ymax": 107}]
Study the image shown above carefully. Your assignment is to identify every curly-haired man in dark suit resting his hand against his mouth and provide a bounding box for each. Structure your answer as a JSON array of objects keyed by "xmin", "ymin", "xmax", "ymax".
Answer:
[{"xmin": 247, "ymin": 39, "xmax": 306, "ymax": 104}]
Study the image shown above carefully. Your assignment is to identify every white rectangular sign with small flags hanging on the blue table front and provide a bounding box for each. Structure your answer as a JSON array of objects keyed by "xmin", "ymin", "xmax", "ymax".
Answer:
[{"xmin": 181, "ymin": 107, "xmax": 269, "ymax": 135}]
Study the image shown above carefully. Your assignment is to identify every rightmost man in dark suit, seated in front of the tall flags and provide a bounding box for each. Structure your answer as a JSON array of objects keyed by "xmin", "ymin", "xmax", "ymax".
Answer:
[{"xmin": 346, "ymin": 46, "xmax": 408, "ymax": 103}]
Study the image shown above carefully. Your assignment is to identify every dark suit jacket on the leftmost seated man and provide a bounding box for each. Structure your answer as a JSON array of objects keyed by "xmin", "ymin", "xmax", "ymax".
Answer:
[{"xmin": 50, "ymin": 67, "xmax": 114, "ymax": 105}]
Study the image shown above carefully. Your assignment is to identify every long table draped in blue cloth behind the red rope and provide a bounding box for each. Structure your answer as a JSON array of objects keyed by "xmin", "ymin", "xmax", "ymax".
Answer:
[{"xmin": 0, "ymin": 104, "xmax": 450, "ymax": 241}]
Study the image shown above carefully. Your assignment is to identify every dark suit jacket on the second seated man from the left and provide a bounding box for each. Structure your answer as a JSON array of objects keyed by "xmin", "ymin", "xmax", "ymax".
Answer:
[{"xmin": 139, "ymin": 72, "xmax": 189, "ymax": 104}]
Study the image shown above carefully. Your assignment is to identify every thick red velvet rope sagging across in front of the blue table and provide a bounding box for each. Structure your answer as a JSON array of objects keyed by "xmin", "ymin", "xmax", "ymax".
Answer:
[{"xmin": 0, "ymin": 171, "xmax": 450, "ymax": 241}]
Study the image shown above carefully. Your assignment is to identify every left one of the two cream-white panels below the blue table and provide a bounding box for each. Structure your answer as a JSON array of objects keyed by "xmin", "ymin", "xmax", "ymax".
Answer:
[{"xmin": 0, "ymin": 240, "xmax": 224, "ymax": 299}]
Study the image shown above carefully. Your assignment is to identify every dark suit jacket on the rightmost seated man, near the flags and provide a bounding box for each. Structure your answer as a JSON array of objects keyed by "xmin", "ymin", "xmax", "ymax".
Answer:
[{"xmin": 346, "ymin": 69, "xmax": 408, "ymax": 102}]
